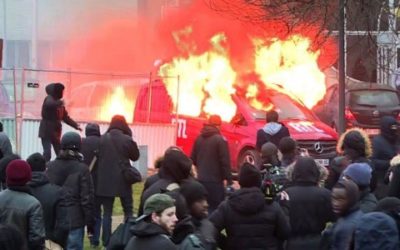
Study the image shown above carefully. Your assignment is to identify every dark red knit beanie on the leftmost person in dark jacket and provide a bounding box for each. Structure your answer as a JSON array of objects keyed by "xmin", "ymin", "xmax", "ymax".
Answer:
[{"xmin": 6, "ymin": 160, "xmax": 32, "ymax": 187}]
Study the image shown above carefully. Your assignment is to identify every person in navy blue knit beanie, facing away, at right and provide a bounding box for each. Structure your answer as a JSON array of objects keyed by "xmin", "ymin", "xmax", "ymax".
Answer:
[{"xmin": 343, "ymin": 162, "xmax": 378, "ymax": 213}]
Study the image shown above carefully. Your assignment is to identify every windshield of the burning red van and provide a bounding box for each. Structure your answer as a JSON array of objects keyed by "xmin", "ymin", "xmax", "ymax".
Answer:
[{"xmin": 252, "ymin": 93, "xmax": 315, "ymax": 121}]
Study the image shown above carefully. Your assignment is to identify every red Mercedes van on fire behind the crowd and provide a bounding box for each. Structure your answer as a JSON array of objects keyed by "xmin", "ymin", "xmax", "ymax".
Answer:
[{"xmin": 134, "ymin": 81, "xmax": 337, "ymax": 172}]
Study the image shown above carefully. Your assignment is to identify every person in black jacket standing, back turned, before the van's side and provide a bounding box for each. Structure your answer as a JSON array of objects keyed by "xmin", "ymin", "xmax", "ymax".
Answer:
[{"xmin": 191, "ymin": 115, "xmax": 233, "ymax": 213}]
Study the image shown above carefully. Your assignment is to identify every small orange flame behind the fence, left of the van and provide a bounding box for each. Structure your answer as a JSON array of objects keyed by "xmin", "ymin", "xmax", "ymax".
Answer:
[{"xmin": 100, "ymin": 86, "xmax": 134, "ymax": 121}]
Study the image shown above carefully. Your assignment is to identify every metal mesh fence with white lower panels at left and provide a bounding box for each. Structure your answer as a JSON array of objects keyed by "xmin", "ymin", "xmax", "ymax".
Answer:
[{"xmin": 0, "ymin": 68, "xmax": 179, "ymax": 167}]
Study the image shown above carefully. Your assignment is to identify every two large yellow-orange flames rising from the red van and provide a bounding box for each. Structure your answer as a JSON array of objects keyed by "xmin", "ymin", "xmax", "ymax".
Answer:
[{"xmin": 159, "ymin": 29, "xmax": 326, "ymax": 121}]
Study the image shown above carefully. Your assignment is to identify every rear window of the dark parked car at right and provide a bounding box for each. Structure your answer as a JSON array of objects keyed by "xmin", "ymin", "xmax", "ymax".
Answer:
[{"xmin": 350, "ymin": 90, "xmax": 400, "ymax": 107}]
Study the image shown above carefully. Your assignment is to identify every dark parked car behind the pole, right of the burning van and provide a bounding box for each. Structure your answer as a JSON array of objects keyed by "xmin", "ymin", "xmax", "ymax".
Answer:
[{"xmin": 313, "ymin": 83, "xmax": 400, "ymax": 136}]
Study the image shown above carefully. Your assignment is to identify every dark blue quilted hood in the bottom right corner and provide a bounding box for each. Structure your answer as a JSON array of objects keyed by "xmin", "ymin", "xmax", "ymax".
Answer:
[{"xmin": 354, "ymin": 212, "xmax": 400, "ymax": 250}]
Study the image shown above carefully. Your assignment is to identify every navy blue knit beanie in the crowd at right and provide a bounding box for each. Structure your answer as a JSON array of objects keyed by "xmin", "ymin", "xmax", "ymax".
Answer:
[{"xmin": 343, "ymin": 162, "xmax": 372, "ymax": 187}]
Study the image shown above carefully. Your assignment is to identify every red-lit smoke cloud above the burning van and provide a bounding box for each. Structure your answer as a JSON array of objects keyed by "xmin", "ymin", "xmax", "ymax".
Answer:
[{"xmin": 50, "ymin": 0, "xmax": 336, "ymax": 73}]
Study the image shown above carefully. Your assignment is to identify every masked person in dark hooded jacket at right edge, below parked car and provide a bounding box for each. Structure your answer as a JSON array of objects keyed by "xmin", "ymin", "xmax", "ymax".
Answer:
[{"xmin": 371, "ymin": 116, "xmax": 400, "ymax": 199}]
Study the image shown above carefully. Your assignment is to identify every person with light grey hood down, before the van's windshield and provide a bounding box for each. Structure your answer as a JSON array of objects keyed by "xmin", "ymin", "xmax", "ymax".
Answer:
[{"xmin": 256, "ymin": 110, "xmax": 290, "ymax": 150}]
